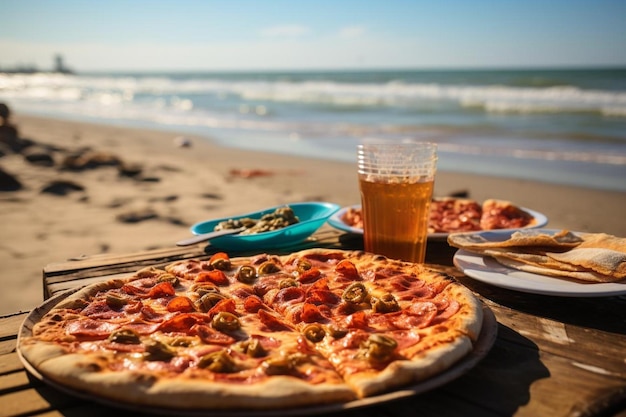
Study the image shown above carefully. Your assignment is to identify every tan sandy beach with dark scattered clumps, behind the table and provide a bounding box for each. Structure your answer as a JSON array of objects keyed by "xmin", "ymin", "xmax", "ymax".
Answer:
[{"xmin": 0, "ymin": 114, "xmax": 626, "ymax": 314}]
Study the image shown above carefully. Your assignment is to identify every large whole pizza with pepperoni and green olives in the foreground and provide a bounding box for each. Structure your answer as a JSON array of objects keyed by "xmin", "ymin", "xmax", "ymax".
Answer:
[{"xmin": 18, "ymin": 249, "xmax": 483, "ymax": 410}]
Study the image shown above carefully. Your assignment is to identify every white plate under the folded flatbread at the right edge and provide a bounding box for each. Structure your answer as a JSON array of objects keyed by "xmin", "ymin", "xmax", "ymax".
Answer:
[{"xmin": 453, "ymin": 245, "xmax": 626, "ymax": 297}]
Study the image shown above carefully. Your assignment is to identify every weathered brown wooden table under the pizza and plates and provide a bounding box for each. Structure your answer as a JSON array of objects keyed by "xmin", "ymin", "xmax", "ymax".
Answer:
[{"xmin": 0, "ymin": 226, "xmax": 626, "ymax": 417}]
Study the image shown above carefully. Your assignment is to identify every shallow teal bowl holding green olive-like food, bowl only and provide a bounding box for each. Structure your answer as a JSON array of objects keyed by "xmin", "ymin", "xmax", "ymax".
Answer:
[{"xmin": 191, "ymin": 202, "xmax": 341, "ymax": 251}]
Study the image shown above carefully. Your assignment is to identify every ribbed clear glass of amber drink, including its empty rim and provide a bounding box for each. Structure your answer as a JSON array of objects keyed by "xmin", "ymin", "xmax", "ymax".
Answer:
[{"xmin": 358, "ymin": 141, "xmax": 437, "ymax": 263}]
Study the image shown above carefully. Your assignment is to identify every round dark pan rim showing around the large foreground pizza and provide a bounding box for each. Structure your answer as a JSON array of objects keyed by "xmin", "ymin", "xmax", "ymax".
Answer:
[{"xmin": 17, "ymin": 289, "xmax": 498, "ymax": 417}]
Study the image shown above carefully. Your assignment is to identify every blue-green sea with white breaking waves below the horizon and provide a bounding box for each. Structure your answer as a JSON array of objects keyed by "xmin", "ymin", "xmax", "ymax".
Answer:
[{"xmin": 0, "ymin": 69, "xmax": 626, "ymax": 191}]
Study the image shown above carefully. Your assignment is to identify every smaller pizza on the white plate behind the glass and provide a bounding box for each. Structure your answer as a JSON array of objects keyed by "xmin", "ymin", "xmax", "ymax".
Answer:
[{"xmin": 341, "ymin": 197, "xmax": 535, "ymax": 233}]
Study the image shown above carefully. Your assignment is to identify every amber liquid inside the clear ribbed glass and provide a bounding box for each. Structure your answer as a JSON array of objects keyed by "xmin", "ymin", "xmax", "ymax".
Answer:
[{"xmin": 359, "ymin": 178, "xmax": 434, "ymax": 263}]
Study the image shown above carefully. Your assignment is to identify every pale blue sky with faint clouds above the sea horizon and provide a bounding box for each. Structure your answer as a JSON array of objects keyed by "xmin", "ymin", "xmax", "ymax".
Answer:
[{"xmin": 0, "ymin": 0, "xmax": 626, "ymax": 71}]
